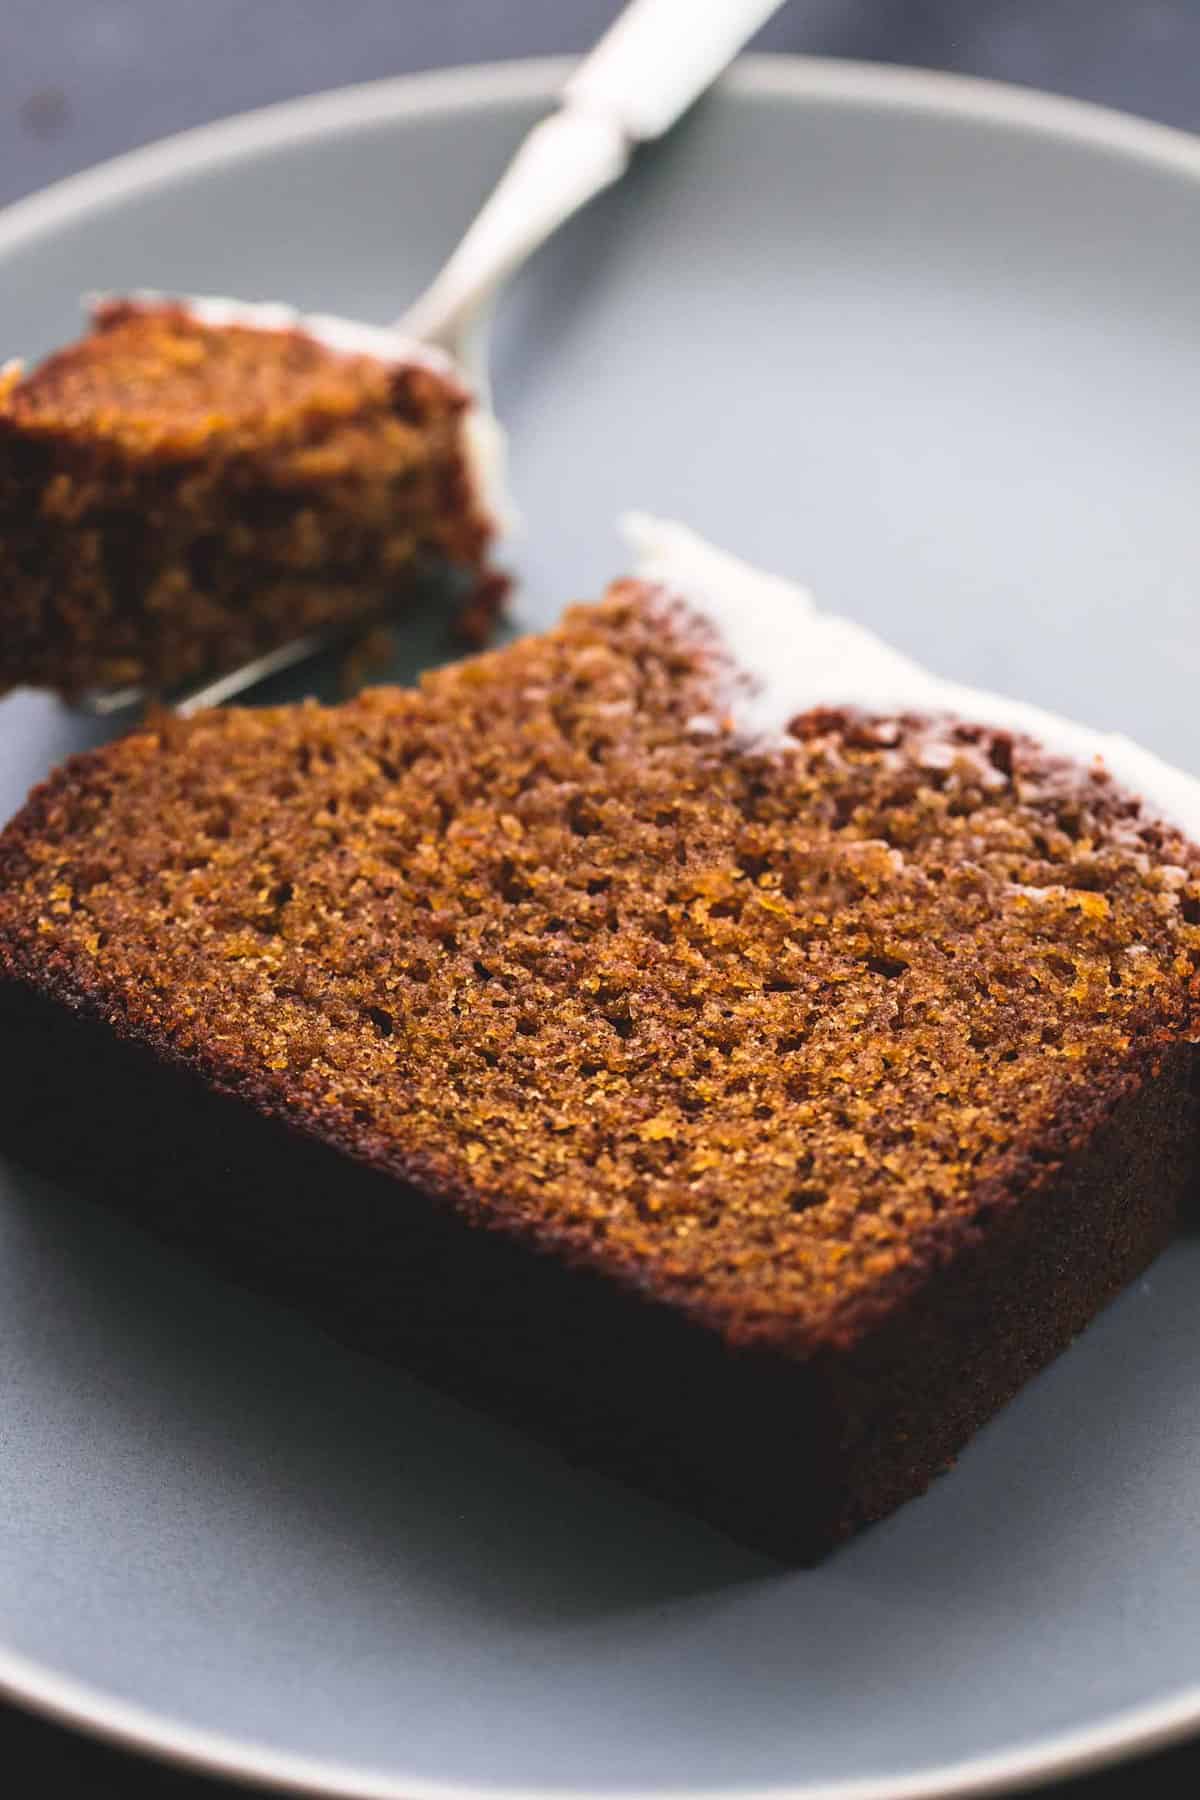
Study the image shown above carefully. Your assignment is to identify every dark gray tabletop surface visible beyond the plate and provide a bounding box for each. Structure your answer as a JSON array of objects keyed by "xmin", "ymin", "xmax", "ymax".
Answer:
[{"xmin": 0, "ymin": 0, "xmax": 1200, "ymax": 1800}]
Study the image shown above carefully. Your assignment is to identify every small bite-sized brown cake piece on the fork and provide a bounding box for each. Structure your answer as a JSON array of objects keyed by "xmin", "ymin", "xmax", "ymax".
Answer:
[{"xmin": 0, "ymin": 302, "xmax": 502, "ymax": 695}]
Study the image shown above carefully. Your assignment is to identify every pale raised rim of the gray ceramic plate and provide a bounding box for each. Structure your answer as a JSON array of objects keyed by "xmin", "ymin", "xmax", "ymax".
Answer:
[{"xmin": 0, "ymin": 52, "xmax": 1200, "ymax": 1800}]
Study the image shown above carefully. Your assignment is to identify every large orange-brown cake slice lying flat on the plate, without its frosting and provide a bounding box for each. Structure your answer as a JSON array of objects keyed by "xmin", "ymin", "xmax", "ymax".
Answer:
[{"xmin": 0, "ymin": 583, "xmax": 1200, "ymax": 1557}]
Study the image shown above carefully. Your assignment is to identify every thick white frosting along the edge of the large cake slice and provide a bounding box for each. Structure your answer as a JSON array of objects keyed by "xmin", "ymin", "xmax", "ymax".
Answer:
[{"xmin": 621, "ymin": 513, "xmax": 1200, "ymax": 841}]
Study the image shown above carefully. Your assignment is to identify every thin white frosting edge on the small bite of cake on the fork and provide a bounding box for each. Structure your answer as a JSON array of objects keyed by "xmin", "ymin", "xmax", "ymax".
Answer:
[{"xmin": 86, "ymin": 288, "xmax": 515, "ymax": 535}]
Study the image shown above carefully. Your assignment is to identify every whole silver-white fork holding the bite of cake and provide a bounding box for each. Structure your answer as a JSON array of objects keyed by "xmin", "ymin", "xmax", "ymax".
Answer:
[{"xmin": 83, "ymin": 0, "xmax": 781, "ymax": 716}]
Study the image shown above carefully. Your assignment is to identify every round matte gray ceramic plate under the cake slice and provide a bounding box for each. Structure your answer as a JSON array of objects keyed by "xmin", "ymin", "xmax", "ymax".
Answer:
[{"xmin": 0, "ymin": 59, "xmax": 1200, "ymax": 1800}]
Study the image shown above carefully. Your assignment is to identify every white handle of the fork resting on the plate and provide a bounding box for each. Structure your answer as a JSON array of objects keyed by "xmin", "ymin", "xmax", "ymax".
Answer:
[{"xmin": 399, "ymin": 0, "xmax": 781, "ymax": 355}]
